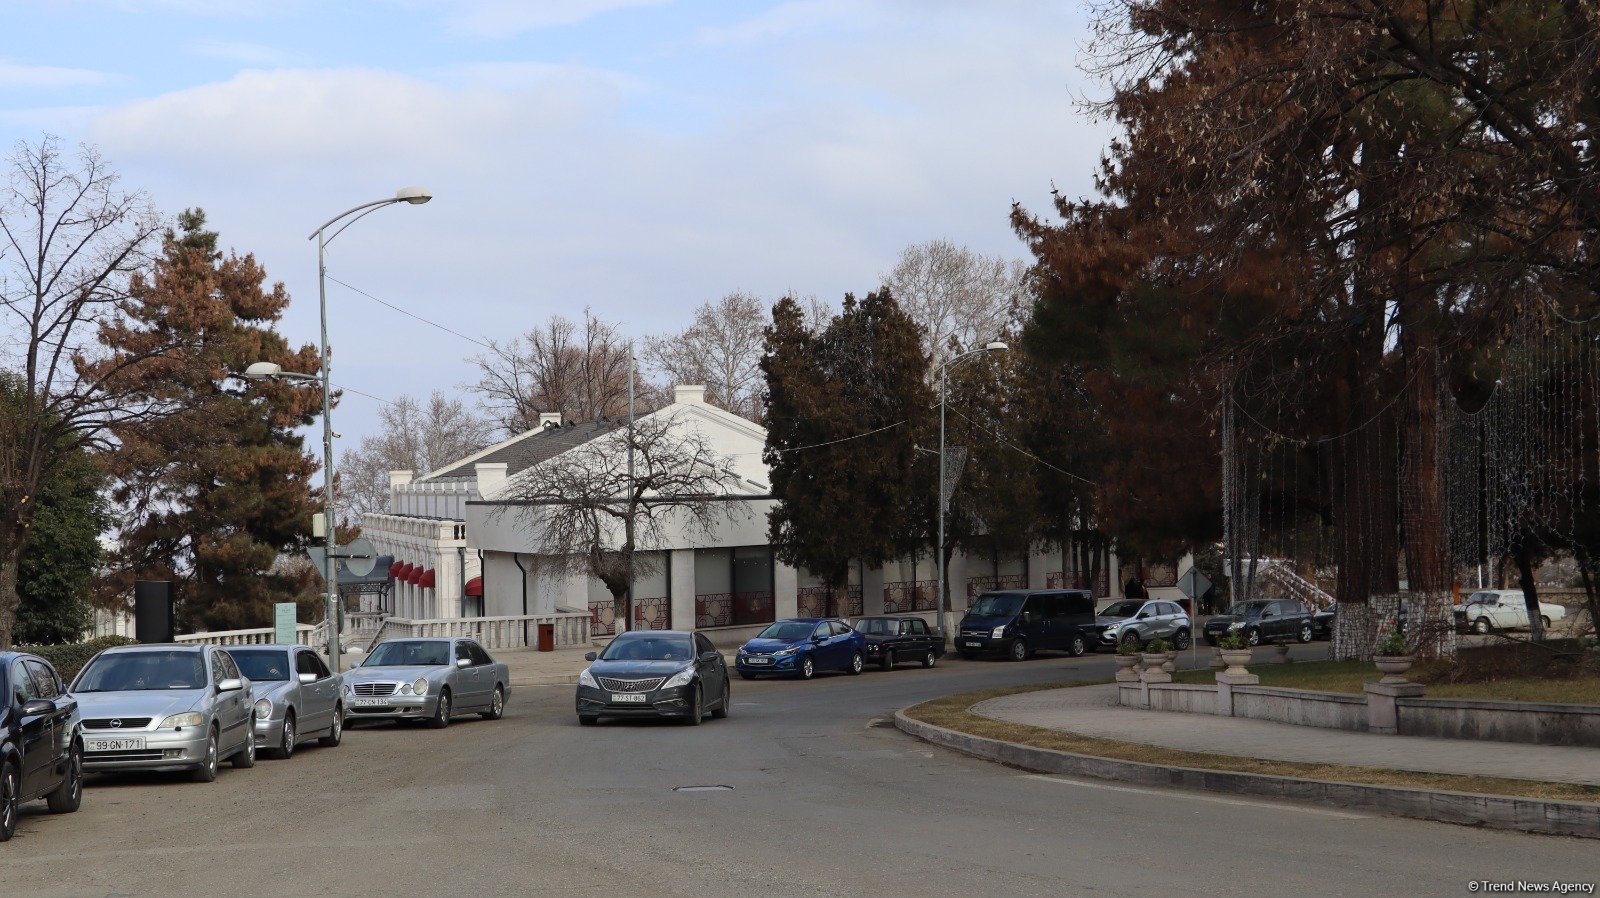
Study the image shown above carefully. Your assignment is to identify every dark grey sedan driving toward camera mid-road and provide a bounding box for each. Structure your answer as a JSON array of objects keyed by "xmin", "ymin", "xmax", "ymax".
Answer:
[{"xmin": 578, "ymin": 631, "xmax": 733, "ymax": 727}]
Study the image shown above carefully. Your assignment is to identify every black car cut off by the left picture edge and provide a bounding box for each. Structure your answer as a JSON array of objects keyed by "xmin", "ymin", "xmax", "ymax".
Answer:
[{"xmin": 0, "ymin": 651, "xmax": 83, "ymax": 842}]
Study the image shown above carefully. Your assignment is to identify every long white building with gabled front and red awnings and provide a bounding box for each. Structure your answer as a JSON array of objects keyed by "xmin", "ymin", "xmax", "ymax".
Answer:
[{"xmin": 363, "ymin": 386, "xmax": 1179, "ymax": 640}]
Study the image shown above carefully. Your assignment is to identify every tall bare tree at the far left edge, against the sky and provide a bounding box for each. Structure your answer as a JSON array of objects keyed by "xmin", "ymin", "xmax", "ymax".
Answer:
[{"xmin": 0, "ymin": 136, "xmax": 167, "ymax": 648}]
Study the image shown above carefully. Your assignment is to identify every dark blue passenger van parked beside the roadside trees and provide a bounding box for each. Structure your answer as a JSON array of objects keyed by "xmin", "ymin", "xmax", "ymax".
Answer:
[{"xmin": 955, "ymin": 589, "xmax": 1101, "ymax": 661}]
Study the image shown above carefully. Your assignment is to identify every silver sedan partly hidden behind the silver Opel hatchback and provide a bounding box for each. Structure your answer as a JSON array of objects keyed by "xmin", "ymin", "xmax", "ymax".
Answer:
[{"xmin": 227, "ymin": 645, "xmax": 344, "ymax": 760}]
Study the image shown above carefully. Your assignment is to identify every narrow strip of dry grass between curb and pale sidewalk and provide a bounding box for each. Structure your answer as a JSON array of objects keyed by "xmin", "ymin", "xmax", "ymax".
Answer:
[{"xmin": 906, "ymin": 682, "xmax": 1600, "ymax": 802}]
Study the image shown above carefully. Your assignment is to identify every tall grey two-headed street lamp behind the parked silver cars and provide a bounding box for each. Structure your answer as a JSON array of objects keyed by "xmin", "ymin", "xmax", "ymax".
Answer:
[{"xmin": 245, "ymin": 187, "xmax": 434, "ymax": 674}]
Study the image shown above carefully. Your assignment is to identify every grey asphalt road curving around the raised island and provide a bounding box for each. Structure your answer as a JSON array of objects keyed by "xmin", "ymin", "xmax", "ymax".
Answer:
[{"xmin": 0, "ymin": 646, "xmax": 1600, "ymax": 898}]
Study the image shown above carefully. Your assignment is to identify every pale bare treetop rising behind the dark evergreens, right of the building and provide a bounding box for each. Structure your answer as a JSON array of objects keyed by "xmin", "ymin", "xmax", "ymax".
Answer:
[{"xmin": 883, "ymin": 240, "xmax": 1029, "ymax": 371}]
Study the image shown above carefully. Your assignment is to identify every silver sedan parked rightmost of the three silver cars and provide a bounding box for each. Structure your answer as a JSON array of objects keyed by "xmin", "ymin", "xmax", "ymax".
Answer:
[{"xmin": 344, "ymin": 637, "xmax": 510, "ymax": 728}]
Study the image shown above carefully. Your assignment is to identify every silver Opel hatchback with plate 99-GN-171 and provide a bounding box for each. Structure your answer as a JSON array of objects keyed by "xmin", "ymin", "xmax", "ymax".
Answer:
[{"xmin": 70, "ymin": 645, "xmax": 256, "ymax": 783}]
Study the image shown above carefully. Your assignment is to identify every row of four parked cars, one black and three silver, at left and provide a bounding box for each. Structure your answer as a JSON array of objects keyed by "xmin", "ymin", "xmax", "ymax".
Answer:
[{"xmin": 0, "ymin": 637, "xmax": 510, "ymax": 842}]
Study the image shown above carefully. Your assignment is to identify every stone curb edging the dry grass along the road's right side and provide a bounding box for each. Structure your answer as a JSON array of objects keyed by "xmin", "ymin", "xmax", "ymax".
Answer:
[{"xmin": 894, "ymin": 711, "xmax": 1600, "ymax": 839}]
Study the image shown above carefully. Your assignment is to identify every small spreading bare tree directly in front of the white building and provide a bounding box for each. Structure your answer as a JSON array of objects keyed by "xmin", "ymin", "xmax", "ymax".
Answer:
[{"xmin": 489, "ymin": 410, "xmax": 739, "ymax": 621}]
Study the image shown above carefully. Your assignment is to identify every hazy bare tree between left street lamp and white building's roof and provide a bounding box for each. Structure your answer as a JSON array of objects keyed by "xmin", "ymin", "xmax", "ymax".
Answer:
[{"xmin": 339, "ymin": 391, "xmax": 494, "ymax": 527}]
